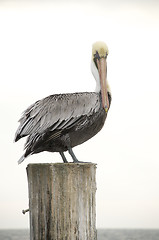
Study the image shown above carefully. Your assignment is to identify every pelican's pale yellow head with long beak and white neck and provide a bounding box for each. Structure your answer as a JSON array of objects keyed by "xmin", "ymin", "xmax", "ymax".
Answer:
[{"xmin": 91, "ymin": 42, "xmax": 109, "ymax": 112}]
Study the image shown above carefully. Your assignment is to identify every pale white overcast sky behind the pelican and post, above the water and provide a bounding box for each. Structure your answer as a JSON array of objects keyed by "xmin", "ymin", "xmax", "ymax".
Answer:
[{"xmin": 0, "ymin": 0, "xmax": 159, "ymax": 228}]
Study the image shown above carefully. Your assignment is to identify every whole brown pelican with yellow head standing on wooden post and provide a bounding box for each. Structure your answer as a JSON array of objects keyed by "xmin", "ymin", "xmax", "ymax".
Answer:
[{"xmin": 15, "ymin": 42, "xmax": 111, "ymax": 164}]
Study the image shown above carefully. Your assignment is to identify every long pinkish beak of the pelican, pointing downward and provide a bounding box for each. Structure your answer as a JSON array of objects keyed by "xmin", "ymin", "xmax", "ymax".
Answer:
[{"xmin": 97, "ymin": 57, "xmax": 109, "ymax": 112}]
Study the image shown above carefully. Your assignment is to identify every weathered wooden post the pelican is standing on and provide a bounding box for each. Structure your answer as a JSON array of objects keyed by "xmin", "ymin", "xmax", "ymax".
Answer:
[{"xmin": 27, "ymin": 163, "xmax": 97, "ymax": 240}]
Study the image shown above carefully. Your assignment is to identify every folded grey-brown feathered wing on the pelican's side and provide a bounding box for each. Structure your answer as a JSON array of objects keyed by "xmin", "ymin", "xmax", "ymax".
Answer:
[{"xmin": 15, "ymin": 92, "xmax": 100, "ymax": 141}]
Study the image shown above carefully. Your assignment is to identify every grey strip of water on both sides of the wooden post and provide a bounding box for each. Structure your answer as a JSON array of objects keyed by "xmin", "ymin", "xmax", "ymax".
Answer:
[{"xmin": 0, "ymin": 229, "xmax": 159, "ymax": 240}]
